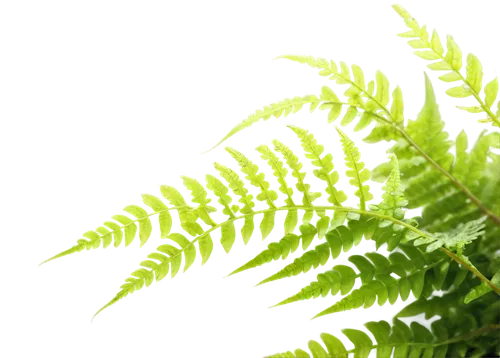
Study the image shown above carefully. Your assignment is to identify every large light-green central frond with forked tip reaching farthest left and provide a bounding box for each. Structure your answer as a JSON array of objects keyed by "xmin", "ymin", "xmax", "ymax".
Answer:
[{"xmin": 44, "ymin": 126, "xmax": 418, "ymax": 322}]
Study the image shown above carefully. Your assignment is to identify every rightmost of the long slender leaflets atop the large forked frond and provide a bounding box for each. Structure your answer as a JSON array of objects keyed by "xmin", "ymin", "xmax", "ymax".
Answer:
[{"xmin": 335, "ymin": 126, "xmax": 375, "ymax": 210}]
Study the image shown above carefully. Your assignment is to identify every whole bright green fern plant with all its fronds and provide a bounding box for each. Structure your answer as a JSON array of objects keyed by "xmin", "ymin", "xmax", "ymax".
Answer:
[{"xmin": 39, "ymin": 3, "xmax": 500, "ymax": 357}]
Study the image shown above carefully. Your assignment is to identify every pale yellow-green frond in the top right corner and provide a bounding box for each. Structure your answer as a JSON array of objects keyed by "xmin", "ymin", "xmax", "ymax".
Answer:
[{"xmin": 391, "ymin": 2, "xmax": 500, "ymax": 128}]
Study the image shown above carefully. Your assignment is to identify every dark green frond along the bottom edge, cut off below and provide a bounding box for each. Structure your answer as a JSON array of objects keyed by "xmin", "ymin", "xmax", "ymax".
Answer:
[{"xmin": 261, "ymin": 287, "xmax": 500, "ymax": 358}]
